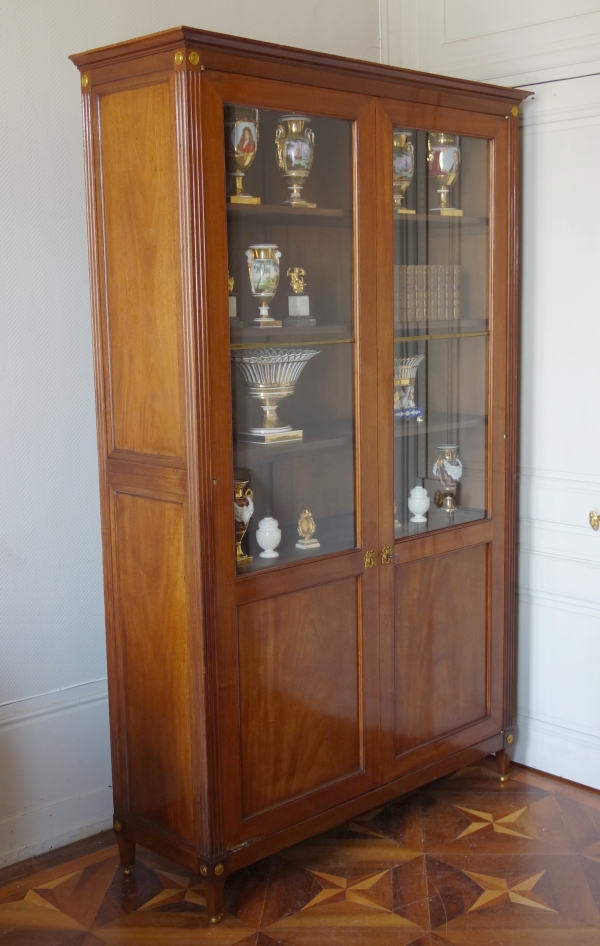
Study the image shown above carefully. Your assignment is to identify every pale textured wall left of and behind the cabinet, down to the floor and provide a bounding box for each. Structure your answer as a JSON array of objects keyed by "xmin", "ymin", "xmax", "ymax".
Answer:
[{"xmin": 0, "ymin": 0, "xmax": 379, "ymax": 863}]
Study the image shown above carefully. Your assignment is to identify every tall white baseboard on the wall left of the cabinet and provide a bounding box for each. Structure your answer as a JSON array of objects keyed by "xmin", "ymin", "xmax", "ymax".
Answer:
[{"xmin": 0, "ymin": 680, "xmax": 113, "ymax": 865}]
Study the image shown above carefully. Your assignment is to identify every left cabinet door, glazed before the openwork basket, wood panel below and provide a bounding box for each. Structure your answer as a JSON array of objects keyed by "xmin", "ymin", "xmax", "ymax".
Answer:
[{"xmin": 202, "ymin": 70, "xmax": 378, "ymax": 847}]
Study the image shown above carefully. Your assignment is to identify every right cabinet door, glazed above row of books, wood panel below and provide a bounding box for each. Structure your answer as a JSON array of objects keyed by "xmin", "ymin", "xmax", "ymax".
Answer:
[{"xmin": 378, "ymin": 103, "xmax": 514, "ymax": 778}]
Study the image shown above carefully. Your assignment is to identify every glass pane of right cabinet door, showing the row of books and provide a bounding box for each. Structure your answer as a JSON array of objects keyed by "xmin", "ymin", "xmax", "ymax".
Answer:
[{"xmin": 392, "ymin": 128, "xmax": 489, "ymax": 539}]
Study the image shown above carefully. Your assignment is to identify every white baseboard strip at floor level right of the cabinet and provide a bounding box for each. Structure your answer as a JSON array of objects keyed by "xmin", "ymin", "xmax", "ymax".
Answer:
[{"xmin": 514, "ymin": 715, "xmax": 600, "ymax": 789}]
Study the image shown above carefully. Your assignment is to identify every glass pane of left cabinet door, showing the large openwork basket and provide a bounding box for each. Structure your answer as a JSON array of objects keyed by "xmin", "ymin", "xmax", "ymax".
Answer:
[{"xmin": 224, "ymin": 103, "xmax": 356, "ymax": 575}]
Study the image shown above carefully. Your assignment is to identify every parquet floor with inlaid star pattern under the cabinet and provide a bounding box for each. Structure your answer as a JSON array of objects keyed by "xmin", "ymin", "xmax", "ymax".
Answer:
[{"xmin": 0, "ymin": 760, "xmax": 600, "ymax": 946}]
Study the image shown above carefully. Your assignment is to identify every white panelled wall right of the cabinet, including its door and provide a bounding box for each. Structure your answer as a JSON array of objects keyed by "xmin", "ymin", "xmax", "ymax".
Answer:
[{"xmin": 382, "ymin": 0, "xmax": 600, "ymax": 788}]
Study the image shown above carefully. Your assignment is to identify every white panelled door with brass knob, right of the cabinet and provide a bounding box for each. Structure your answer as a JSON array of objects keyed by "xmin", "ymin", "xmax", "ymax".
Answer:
[{"xmin": 518, "ymin": 76, "xmax": 600, "ymax": 787}]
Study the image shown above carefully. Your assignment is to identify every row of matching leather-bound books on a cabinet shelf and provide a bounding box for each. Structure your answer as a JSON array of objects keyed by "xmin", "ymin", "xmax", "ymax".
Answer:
[{"xmin": 394, "ymin": 264, "xmax": 462, "ymax": 322}]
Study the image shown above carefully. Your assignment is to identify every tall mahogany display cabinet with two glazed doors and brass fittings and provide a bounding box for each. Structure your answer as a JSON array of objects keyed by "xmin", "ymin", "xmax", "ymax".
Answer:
[{"xmin": 72, "ymin": 28, "xmax": 526, "ymax": 922}]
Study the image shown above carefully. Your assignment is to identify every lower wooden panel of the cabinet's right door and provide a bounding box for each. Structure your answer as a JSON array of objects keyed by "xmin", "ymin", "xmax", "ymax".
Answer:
[{"xmin": 395, "ymin": 546, "xmax": 488, "ymax": 756}]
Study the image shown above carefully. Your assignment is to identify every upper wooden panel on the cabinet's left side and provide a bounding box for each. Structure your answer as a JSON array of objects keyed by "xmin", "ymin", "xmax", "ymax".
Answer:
[{"xmin": 99, "ymin": 81, "xmax": 183, "ymax": 458}]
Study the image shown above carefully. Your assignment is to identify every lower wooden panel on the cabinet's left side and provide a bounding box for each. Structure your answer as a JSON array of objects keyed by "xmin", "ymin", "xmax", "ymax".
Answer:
[{"xmin": 113, "ymin": 493, "xmax": 193, "ymax": 839}]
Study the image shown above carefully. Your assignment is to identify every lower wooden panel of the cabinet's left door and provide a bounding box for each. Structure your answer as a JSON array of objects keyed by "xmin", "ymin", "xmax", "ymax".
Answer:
[{"xmin": 238, "ymin": 578, "xmax": 363, "ymax": 818}]
